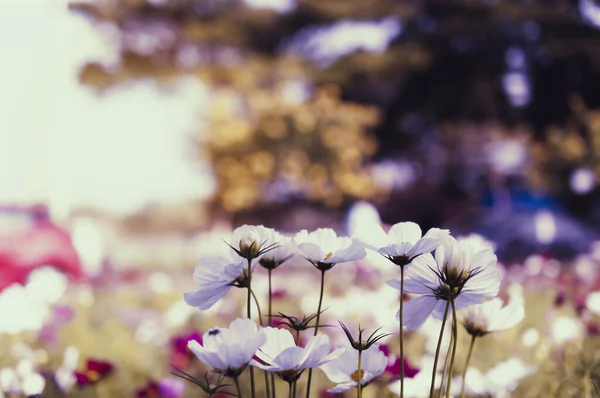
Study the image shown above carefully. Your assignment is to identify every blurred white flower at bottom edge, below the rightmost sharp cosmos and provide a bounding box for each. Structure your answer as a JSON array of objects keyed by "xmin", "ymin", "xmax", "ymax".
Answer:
[{"xmin": 452, "ymin": 358, "xmax": 537, "ymax": 397}]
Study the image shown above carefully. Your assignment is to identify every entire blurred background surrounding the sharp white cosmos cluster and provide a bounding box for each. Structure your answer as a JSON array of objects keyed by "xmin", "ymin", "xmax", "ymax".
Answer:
[{"xmin": 5, "ymin": 0, "xmax": 600, "ymax": 398}]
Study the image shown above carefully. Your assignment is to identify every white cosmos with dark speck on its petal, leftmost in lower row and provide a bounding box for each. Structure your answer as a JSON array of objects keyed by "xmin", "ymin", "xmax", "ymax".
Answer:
[{"xmin": 188, "ymin": 318, "xmax": 266, "ymax": 377}]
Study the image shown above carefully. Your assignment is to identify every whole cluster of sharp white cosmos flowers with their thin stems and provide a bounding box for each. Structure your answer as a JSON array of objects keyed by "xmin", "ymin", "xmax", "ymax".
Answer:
[{"xmin": 184, "ymin": 222, "xmax": 524, "ymax": 398}]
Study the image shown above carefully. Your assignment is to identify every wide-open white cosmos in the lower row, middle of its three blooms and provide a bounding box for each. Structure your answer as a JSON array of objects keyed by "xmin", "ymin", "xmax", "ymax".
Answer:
[{"xmin": 250, "ymin": 327, "xmax": 345, "ymax": 382}]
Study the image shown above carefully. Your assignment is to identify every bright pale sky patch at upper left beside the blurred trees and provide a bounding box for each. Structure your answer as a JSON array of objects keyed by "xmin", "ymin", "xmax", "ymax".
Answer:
[{"xmin": 0, "ymin": 0, "xmax": 212, "ymax": 214}]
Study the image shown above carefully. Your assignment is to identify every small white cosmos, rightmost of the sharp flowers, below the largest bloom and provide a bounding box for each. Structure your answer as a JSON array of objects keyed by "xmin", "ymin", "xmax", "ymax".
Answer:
[{"xmin": 461, "ymin": 297, "xmax": 525, "ymax": 337}]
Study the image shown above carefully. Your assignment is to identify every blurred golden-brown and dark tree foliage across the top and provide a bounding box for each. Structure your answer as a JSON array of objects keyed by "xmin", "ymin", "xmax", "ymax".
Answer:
[{"xmin": 71, "ymin": 0, "xmax": 600, "ymax": 225}]
